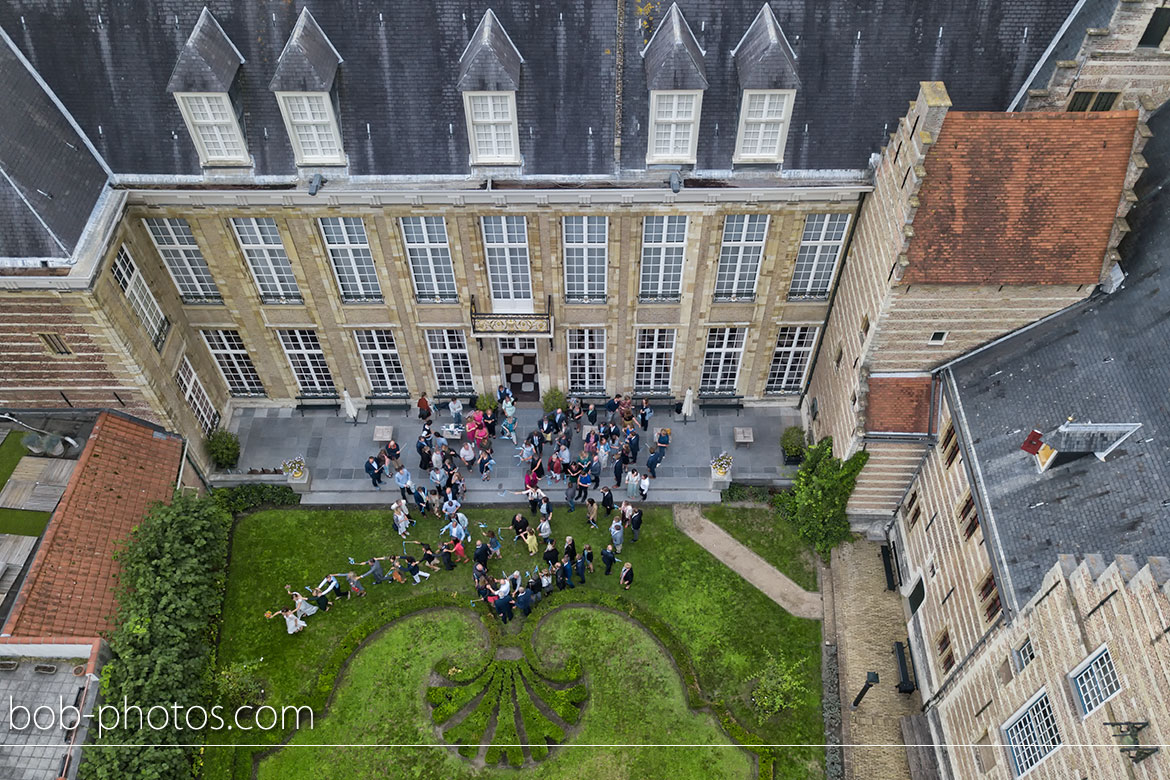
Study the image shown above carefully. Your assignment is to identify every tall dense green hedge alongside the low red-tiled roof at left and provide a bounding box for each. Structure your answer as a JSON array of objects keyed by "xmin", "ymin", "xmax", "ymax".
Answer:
[{"xmin": 80, "ymin": 495, "xmax": 232, "ymax": 780}]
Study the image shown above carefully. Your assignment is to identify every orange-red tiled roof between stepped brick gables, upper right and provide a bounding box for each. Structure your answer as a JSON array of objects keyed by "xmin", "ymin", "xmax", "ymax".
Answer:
[{"xmin": 902, "ymin": 111, "xmax": 1137, "ymax": 284}]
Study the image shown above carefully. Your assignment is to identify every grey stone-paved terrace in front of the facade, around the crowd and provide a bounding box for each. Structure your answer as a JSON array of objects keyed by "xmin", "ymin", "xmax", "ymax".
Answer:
[{"xmin": 222, "ymin": 403, "xmax": 799, "ymax": 505}]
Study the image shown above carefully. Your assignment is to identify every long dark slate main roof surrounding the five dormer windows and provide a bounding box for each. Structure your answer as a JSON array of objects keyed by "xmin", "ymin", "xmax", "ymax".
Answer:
[{"xmin": 0, "ymin": 0, "xmax": 1075, "ymax": 177}]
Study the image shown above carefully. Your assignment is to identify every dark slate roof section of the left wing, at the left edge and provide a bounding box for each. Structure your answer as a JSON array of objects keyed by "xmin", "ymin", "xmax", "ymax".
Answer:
[{"xmin": 0, "ymin": 30, "xmax": 106, "ymax": 258}]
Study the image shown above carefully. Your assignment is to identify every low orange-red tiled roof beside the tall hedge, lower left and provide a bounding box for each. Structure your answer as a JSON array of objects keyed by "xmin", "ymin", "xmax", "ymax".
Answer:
[{"xmin": 4, "ymin": 413, "xmax": 183, "ymax": 637}]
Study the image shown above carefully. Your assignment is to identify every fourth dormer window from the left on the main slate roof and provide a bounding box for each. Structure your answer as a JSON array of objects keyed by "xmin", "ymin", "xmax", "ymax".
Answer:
[{"xmin": 642, "ymin": 5, "xmax": 707, "ymax": 165}]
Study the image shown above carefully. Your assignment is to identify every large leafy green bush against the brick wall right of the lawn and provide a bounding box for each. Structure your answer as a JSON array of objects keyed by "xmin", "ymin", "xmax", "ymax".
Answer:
[{"xmin": 777, "ymin": 436, "xmax": 869, "ymax": 559}]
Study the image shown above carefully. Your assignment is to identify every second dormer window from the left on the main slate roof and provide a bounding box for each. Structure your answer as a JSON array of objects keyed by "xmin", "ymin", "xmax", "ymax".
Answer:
[{"xmin": 268, "ymin": 8, "xmax": 345, "ymax": 165}]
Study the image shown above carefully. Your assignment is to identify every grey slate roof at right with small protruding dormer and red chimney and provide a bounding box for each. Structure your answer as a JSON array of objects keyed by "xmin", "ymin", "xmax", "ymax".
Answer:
[{"xmin": 950, "ymin": 95, "xmax": 1170, "ymax": 608}]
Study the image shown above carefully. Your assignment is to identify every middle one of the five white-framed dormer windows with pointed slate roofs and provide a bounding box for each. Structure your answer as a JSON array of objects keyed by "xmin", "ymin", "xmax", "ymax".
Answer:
[{"xmin": 456, "ymin": 8, "xmax": 524, "ymax": 165}]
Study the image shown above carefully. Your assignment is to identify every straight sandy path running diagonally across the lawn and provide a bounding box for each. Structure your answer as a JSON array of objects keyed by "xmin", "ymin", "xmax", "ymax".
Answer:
[{"xmin": 674, "ymin": 504, "xmax": 824, "ymax": 620}]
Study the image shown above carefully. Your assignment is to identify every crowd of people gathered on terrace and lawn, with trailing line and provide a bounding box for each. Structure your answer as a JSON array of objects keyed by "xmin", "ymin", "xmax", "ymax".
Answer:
[{"xmin": 264, "ymin": 385, "xmax": 670, "ymax": 634}]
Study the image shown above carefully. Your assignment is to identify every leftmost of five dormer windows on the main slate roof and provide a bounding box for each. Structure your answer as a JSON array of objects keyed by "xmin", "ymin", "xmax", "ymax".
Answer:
[{"xmin": 166, "ymin": 7, "xmax": 252, "ymax": 166}]
